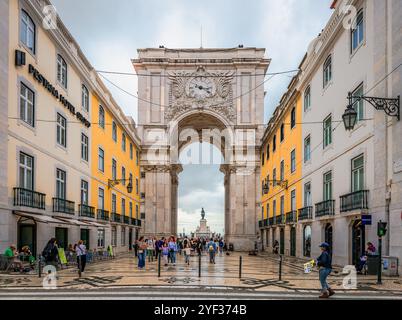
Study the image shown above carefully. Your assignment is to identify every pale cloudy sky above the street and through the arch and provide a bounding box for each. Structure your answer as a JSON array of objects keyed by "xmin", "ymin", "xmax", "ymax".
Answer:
[{"xmin": 52, "ymin": 0, "xmax": 332, "ymax": 232}]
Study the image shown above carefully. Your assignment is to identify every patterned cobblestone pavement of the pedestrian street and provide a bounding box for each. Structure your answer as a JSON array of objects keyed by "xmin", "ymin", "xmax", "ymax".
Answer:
[{"xmin": 0, "ymin": 253, "xmax": 402, "ymax": 298}]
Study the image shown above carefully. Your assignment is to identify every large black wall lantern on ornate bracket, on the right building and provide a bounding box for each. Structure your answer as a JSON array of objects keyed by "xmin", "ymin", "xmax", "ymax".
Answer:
[{"xmin": 342, "ymin": 92, "xmax": 401, "ymax": 131}]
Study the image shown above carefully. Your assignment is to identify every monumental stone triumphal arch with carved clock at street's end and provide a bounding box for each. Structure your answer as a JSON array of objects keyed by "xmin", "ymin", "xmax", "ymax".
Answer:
[{"xmin": 133, "ymin": 48, "xmax": 269, "ymax": 250}]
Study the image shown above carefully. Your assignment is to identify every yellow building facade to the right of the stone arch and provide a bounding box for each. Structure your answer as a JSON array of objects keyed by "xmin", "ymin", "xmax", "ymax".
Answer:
[{"xmin": 259, "ymin": 78, "xmax": 302, "ymax": 256}]
